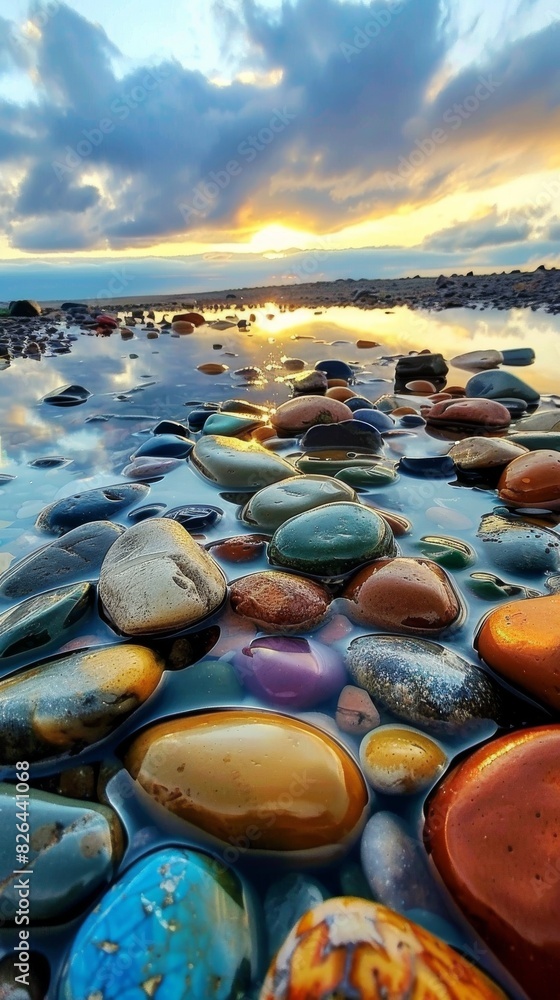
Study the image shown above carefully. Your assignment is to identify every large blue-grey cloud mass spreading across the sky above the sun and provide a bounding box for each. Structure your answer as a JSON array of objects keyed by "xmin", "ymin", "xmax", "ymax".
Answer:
[{"xmin": 0, "ymin": 0, "xmax": 560, "ymax": 251}]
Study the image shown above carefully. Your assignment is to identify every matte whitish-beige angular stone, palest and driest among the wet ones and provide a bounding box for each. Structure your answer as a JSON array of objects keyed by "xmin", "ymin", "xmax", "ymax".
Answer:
[{"xmin": 99, "ymin": 517, "xmax": 227, "ymax": 635}]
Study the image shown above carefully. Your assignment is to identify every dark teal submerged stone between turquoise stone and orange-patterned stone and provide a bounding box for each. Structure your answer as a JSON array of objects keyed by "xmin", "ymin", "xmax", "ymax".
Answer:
[{"xmin": 264, "ymin": 872, "xmax": 330, "ymax": 955}]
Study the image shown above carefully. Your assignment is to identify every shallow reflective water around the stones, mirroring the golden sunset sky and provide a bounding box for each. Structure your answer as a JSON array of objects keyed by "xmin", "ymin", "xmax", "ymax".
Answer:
[{"xmin": 0, "ymin": 304, "xmax": 560, "ymax": 998}]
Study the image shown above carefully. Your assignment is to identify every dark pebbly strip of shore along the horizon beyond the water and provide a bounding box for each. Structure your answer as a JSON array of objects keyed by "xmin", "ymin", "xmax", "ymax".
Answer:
[{"xmin": 4, "ymin": 265, "xmax": 560, "ymax": 314}]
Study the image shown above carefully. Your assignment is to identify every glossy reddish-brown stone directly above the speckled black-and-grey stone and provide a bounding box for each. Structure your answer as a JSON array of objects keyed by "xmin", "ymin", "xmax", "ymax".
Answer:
[{"xmin": 342, "ymin": 556, "xmax": 463, "ymax": 635}]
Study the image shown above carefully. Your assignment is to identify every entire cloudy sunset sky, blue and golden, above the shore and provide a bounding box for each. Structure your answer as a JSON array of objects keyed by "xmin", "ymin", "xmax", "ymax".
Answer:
[{"xmin": 0, "ymin": 0, "xmax": 560, "ymax": 300}]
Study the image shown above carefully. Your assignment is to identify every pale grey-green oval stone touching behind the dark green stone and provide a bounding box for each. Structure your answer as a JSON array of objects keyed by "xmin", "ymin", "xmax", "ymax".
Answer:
[{"xmin": 241, "ymin": 476, "xmax": 356, "ymax": 534}]
